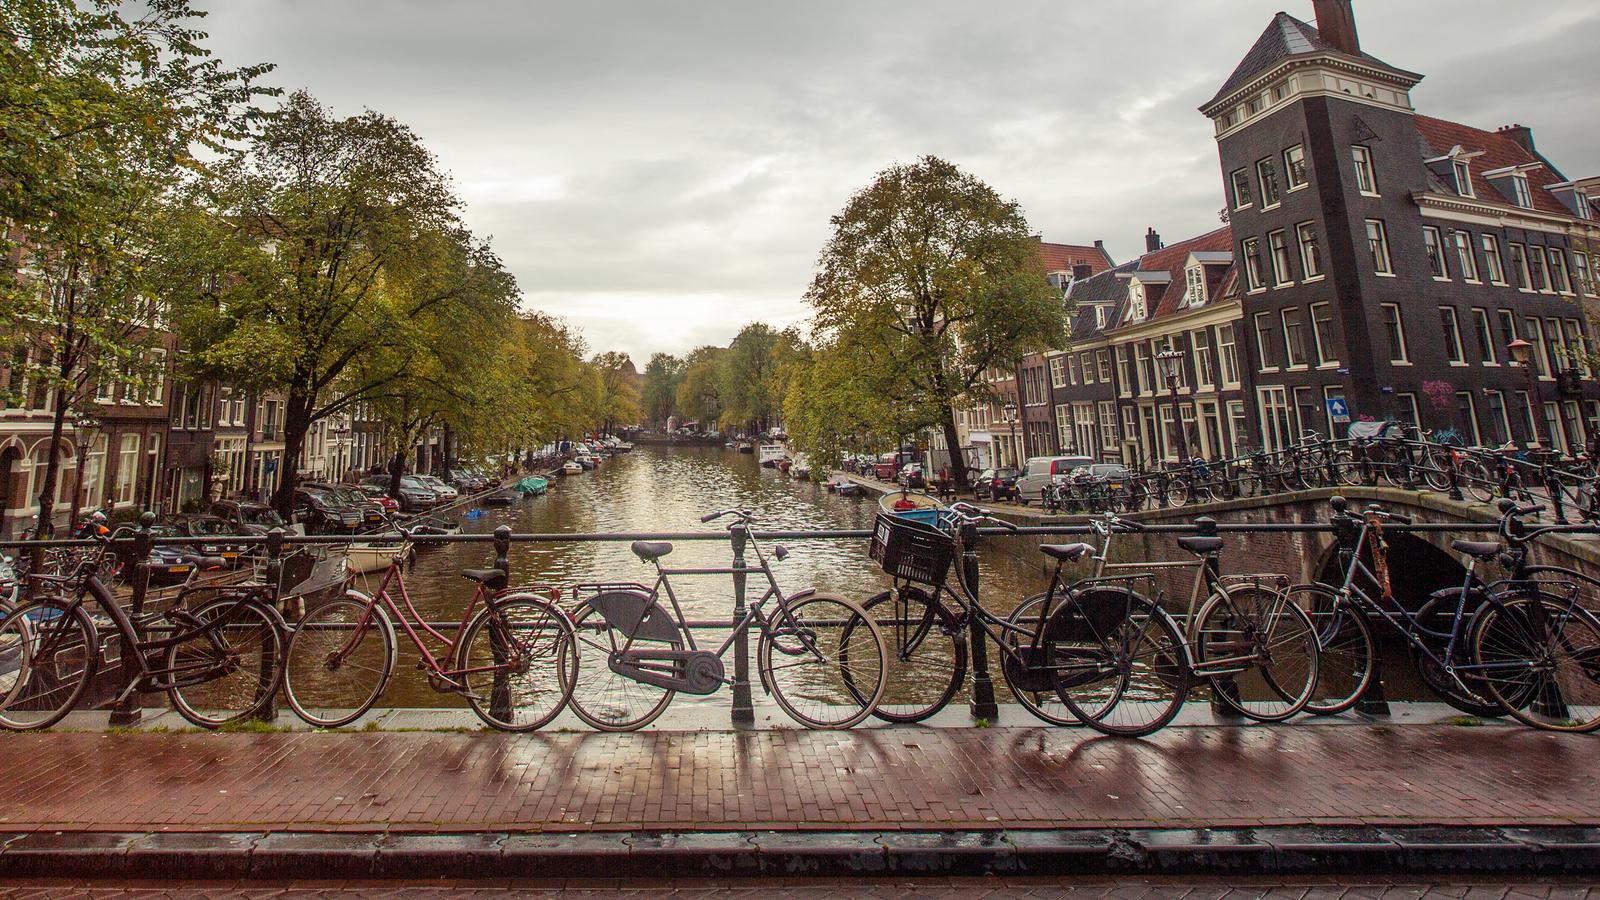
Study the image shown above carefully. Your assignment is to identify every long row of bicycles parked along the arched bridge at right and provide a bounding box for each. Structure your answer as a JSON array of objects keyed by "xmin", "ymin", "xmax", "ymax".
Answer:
[{"xmin": 1038, "ymin": 421, "xmax": 1600, "ymax": 522}]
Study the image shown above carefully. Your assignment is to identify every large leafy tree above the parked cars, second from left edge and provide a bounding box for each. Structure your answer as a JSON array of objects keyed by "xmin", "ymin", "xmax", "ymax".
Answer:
[{"xmin": 184, "ymin": 91, "xmax": 480, "ymax": 514}]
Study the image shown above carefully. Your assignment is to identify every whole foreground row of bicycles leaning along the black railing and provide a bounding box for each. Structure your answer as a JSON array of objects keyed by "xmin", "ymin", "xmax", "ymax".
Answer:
[{"xmin": 0, "ymin": 495, "xmax": 1600, "ymax": 737}]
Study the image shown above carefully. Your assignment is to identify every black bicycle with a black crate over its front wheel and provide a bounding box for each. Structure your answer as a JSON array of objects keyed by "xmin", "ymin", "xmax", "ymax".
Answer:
[{"xmin": 862, "ymin": 503, "xmax": 1189, "ymax": 737}]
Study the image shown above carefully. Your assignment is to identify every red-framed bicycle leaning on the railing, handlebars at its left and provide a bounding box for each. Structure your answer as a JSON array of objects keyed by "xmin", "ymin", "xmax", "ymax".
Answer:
[{"xmin": 283, "ymin": 525, "xmax": 574, "ymax": 732}]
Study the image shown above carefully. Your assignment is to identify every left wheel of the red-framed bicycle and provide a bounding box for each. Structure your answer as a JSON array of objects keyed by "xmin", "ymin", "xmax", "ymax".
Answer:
[{"xmin": 283, "ymin": 591, "xmax": 395, "ymax": 729}]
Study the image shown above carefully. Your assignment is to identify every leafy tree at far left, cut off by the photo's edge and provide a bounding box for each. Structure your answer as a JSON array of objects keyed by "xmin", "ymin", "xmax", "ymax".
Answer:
[{"xmin": 0, "ymin": 0, "xmax": 270, "ymax": 536}]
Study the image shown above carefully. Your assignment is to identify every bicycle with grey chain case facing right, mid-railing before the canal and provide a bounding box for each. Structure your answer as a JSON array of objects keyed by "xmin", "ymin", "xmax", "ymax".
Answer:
[{"xmin": 563, "ymin": 509, "xmax": 886, "ymax": 732}]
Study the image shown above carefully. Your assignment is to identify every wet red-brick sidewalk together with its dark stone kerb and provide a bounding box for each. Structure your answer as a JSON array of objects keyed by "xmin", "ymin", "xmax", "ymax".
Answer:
[{"xmin": 0, "ymin": 722, "xmax": 1600, "ymax": 878}]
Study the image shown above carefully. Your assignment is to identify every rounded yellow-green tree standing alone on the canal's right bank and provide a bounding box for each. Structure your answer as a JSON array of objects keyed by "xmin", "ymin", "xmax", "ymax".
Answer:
[{"xmin": 806, "ymin": 157, "xmax": 1067, "ymax": 487}]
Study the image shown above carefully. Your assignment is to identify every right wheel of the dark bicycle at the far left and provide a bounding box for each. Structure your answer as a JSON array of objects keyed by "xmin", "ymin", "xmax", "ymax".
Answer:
[{"xmin": 167, "ymin": 597, "xmax": 288, "ymax": 729}]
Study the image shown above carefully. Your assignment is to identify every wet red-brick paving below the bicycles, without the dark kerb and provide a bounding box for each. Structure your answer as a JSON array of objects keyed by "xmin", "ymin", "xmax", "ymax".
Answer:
[{"xmin": 0, "ymin": 722, "xmax": 1600, "ymax": 833}]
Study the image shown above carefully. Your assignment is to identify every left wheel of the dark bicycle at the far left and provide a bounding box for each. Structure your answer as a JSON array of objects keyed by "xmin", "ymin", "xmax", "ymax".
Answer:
[{"xmin": 0, "ymin": 601, "xmax": 99, "ymax": 732}]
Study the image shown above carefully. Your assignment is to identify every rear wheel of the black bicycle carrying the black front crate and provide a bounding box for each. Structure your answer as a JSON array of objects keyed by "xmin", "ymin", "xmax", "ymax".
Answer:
[{"xmin": 1050, "ymin": 588, "xmax": 1192, "ymax": 737}]
